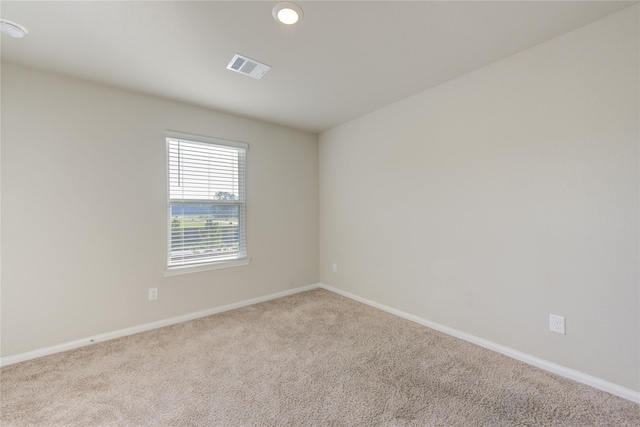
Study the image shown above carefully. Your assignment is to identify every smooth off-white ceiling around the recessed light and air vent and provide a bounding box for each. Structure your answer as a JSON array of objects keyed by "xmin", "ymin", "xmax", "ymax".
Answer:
[{"xmin": 0, "ymin": 0, "xmax": 637, "ymax": 132}]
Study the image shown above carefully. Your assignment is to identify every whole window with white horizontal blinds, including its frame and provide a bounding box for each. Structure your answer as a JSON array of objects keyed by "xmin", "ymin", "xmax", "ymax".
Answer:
[{"xmin": 166, "ymin": 132, "xmax": 249, "ymax": 274}]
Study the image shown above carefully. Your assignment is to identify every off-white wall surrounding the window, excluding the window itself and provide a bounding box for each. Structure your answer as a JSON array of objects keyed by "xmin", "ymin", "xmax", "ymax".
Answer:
[{"xmin": 2, "ymin": 64, "xmax": 318, "ymax": 357}]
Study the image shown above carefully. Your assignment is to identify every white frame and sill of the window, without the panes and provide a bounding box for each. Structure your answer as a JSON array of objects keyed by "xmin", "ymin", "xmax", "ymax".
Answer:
[{"xmin": 164, "ymin": 131, "xmax": 251, "ymax": 276}]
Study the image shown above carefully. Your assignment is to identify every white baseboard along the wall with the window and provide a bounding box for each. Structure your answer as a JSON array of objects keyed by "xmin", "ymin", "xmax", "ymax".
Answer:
[{"xmin": 0, "ymin": 284, "xmax": 320, "ymax": 366}]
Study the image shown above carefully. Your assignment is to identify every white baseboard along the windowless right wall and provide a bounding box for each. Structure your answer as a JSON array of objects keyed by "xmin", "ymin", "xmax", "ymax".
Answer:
[{"xmin": 319, "ymin": 283, "xmax": 640, "ymax": 403}]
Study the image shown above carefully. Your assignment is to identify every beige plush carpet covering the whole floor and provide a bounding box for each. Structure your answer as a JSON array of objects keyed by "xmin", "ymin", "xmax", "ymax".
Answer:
[{"xmin": 1, "ymin": 290, "xmax": 640, "ymax": 426}]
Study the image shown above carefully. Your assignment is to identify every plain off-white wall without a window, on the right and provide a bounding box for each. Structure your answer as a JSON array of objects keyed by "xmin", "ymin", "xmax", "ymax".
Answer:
[{"xmin": 320, "ymin": 6, "xmax": 640, "ymax": 390}]
